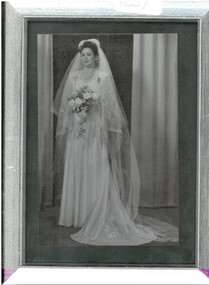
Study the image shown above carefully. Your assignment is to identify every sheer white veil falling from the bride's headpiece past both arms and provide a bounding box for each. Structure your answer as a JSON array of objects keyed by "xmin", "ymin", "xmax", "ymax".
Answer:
[{"xmin": 52, "ymin": 39, "xmax": 140, "ymax": 217}]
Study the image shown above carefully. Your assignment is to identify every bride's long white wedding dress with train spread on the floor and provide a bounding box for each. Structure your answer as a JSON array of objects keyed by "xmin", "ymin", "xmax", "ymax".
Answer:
[{"xmin": 58, "ymin": 71, "xmax": 178, "ymax": 245}]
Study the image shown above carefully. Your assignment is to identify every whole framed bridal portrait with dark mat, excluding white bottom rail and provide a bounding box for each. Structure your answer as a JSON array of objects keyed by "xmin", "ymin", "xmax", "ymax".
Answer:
[{"xmin": 3, "ymin": 0, "xmax": 209, "ymax": 278}]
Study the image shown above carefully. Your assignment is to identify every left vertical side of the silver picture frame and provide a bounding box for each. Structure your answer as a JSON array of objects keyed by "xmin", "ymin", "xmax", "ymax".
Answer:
[{"xmin": 3, "ymin": 2, "xmax": 24, "ymax": 271}]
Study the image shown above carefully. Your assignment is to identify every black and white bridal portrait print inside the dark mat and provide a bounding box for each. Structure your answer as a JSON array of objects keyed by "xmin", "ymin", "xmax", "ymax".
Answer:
[{"xmin": 37, "ymin": 33, "xmax": 179, "ymax": 246}]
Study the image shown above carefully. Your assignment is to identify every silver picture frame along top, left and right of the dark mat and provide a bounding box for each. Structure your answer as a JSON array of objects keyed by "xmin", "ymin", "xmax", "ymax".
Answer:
[{"xmin": 3, "ymin": 2, "xmax": 209, "ymax": 276}]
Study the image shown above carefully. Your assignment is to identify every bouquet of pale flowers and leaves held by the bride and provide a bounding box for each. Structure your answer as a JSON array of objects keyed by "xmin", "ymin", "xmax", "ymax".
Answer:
[{"xmin": 69, "ymin": 86, "xmax": 99, "ymax": 123}]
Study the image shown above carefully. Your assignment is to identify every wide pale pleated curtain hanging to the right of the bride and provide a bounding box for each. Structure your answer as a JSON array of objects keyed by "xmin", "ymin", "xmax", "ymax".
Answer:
[{"xmin": 131, "ymin": 34, "xmax": 178, "ymax": 207}]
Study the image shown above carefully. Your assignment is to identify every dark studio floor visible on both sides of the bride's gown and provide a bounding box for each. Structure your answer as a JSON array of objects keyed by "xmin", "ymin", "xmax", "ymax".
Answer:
[{"xmin": 39, "ymin": 206, "xmax": 179, "ymax": 246}]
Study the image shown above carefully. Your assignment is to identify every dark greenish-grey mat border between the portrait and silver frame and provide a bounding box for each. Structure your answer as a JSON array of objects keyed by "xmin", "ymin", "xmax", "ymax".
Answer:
[{"xmin": 25, "ymin": 20, "xmax": 197, "ymax": 266}]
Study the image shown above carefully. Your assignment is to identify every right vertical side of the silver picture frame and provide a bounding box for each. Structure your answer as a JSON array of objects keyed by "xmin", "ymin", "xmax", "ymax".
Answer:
[{"xmin": 197, "ymin": 12, "xmax": 209, "ymax": 269}]
